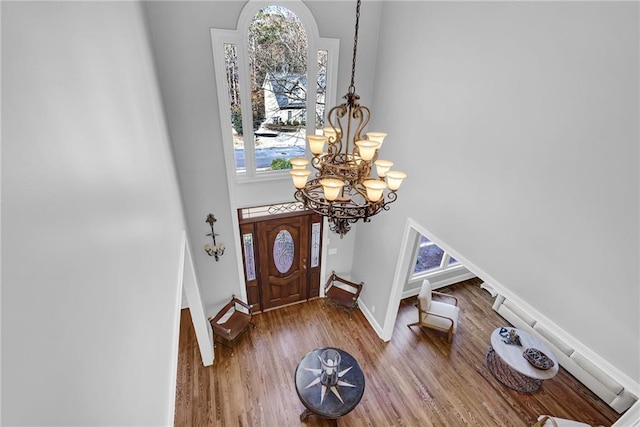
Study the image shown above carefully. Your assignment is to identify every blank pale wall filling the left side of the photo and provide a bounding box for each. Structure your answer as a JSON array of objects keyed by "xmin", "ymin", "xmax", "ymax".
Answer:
[{"xmin": 1, "ymin": 1, "xmax": 184, "ymax": 426}]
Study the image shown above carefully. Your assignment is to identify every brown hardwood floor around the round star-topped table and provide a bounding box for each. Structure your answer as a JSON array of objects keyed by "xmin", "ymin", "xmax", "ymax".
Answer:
[{"xmin": 175, "ymin": 279, "xmax": 619, "ymax": 426}]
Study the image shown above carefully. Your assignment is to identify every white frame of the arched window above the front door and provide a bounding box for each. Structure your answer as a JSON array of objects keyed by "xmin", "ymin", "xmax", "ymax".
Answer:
[{"xmin": 211, "ymin": 0, "xmax": 340, "ymax": 184}]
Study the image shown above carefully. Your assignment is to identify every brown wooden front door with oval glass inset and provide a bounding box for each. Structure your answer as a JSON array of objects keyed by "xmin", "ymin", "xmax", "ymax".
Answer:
[{"xmin": 257, "ymin": 215, "xmax": 309, "ymax": 310}]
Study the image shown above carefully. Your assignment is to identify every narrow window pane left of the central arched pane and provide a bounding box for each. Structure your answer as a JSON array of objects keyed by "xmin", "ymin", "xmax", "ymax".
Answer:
[{"xmin": 224, "ymin": 43, "xmax": 245, "ymax": 172}]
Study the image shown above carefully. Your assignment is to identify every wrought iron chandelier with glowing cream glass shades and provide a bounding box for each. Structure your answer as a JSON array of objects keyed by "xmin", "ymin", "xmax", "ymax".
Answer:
[{"xmin": 289, "ymin": 0, "xmax": 407, "ymax": 237}]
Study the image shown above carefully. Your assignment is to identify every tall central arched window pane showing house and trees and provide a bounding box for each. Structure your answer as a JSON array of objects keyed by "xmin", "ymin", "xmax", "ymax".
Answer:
[{"xmin": 248, "ymin": 6, "xmax": 308, "ymax": 171}]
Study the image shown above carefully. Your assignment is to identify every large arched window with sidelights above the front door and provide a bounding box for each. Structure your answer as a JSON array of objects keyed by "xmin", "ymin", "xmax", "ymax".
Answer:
[{"xmin": 211, "ymin": 2, "xmax": 339, "ymax": 182}]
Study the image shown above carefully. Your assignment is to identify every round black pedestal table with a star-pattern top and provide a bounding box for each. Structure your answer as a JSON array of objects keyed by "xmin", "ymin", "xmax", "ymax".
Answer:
[{"xmin": 295, "ymin": 347, "xmax": 365, "ymax": 421}]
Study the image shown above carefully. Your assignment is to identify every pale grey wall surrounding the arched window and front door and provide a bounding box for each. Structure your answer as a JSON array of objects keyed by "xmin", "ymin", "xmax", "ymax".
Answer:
[{"xmin": 146, "ymin": 1, "xmax": 380, "ymax": 314}]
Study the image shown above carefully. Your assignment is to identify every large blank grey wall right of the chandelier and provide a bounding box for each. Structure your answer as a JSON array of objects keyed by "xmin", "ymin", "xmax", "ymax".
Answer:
[{"xmin": 354, "ymin": 2, "xmax": 640, "ymax": 382}]
